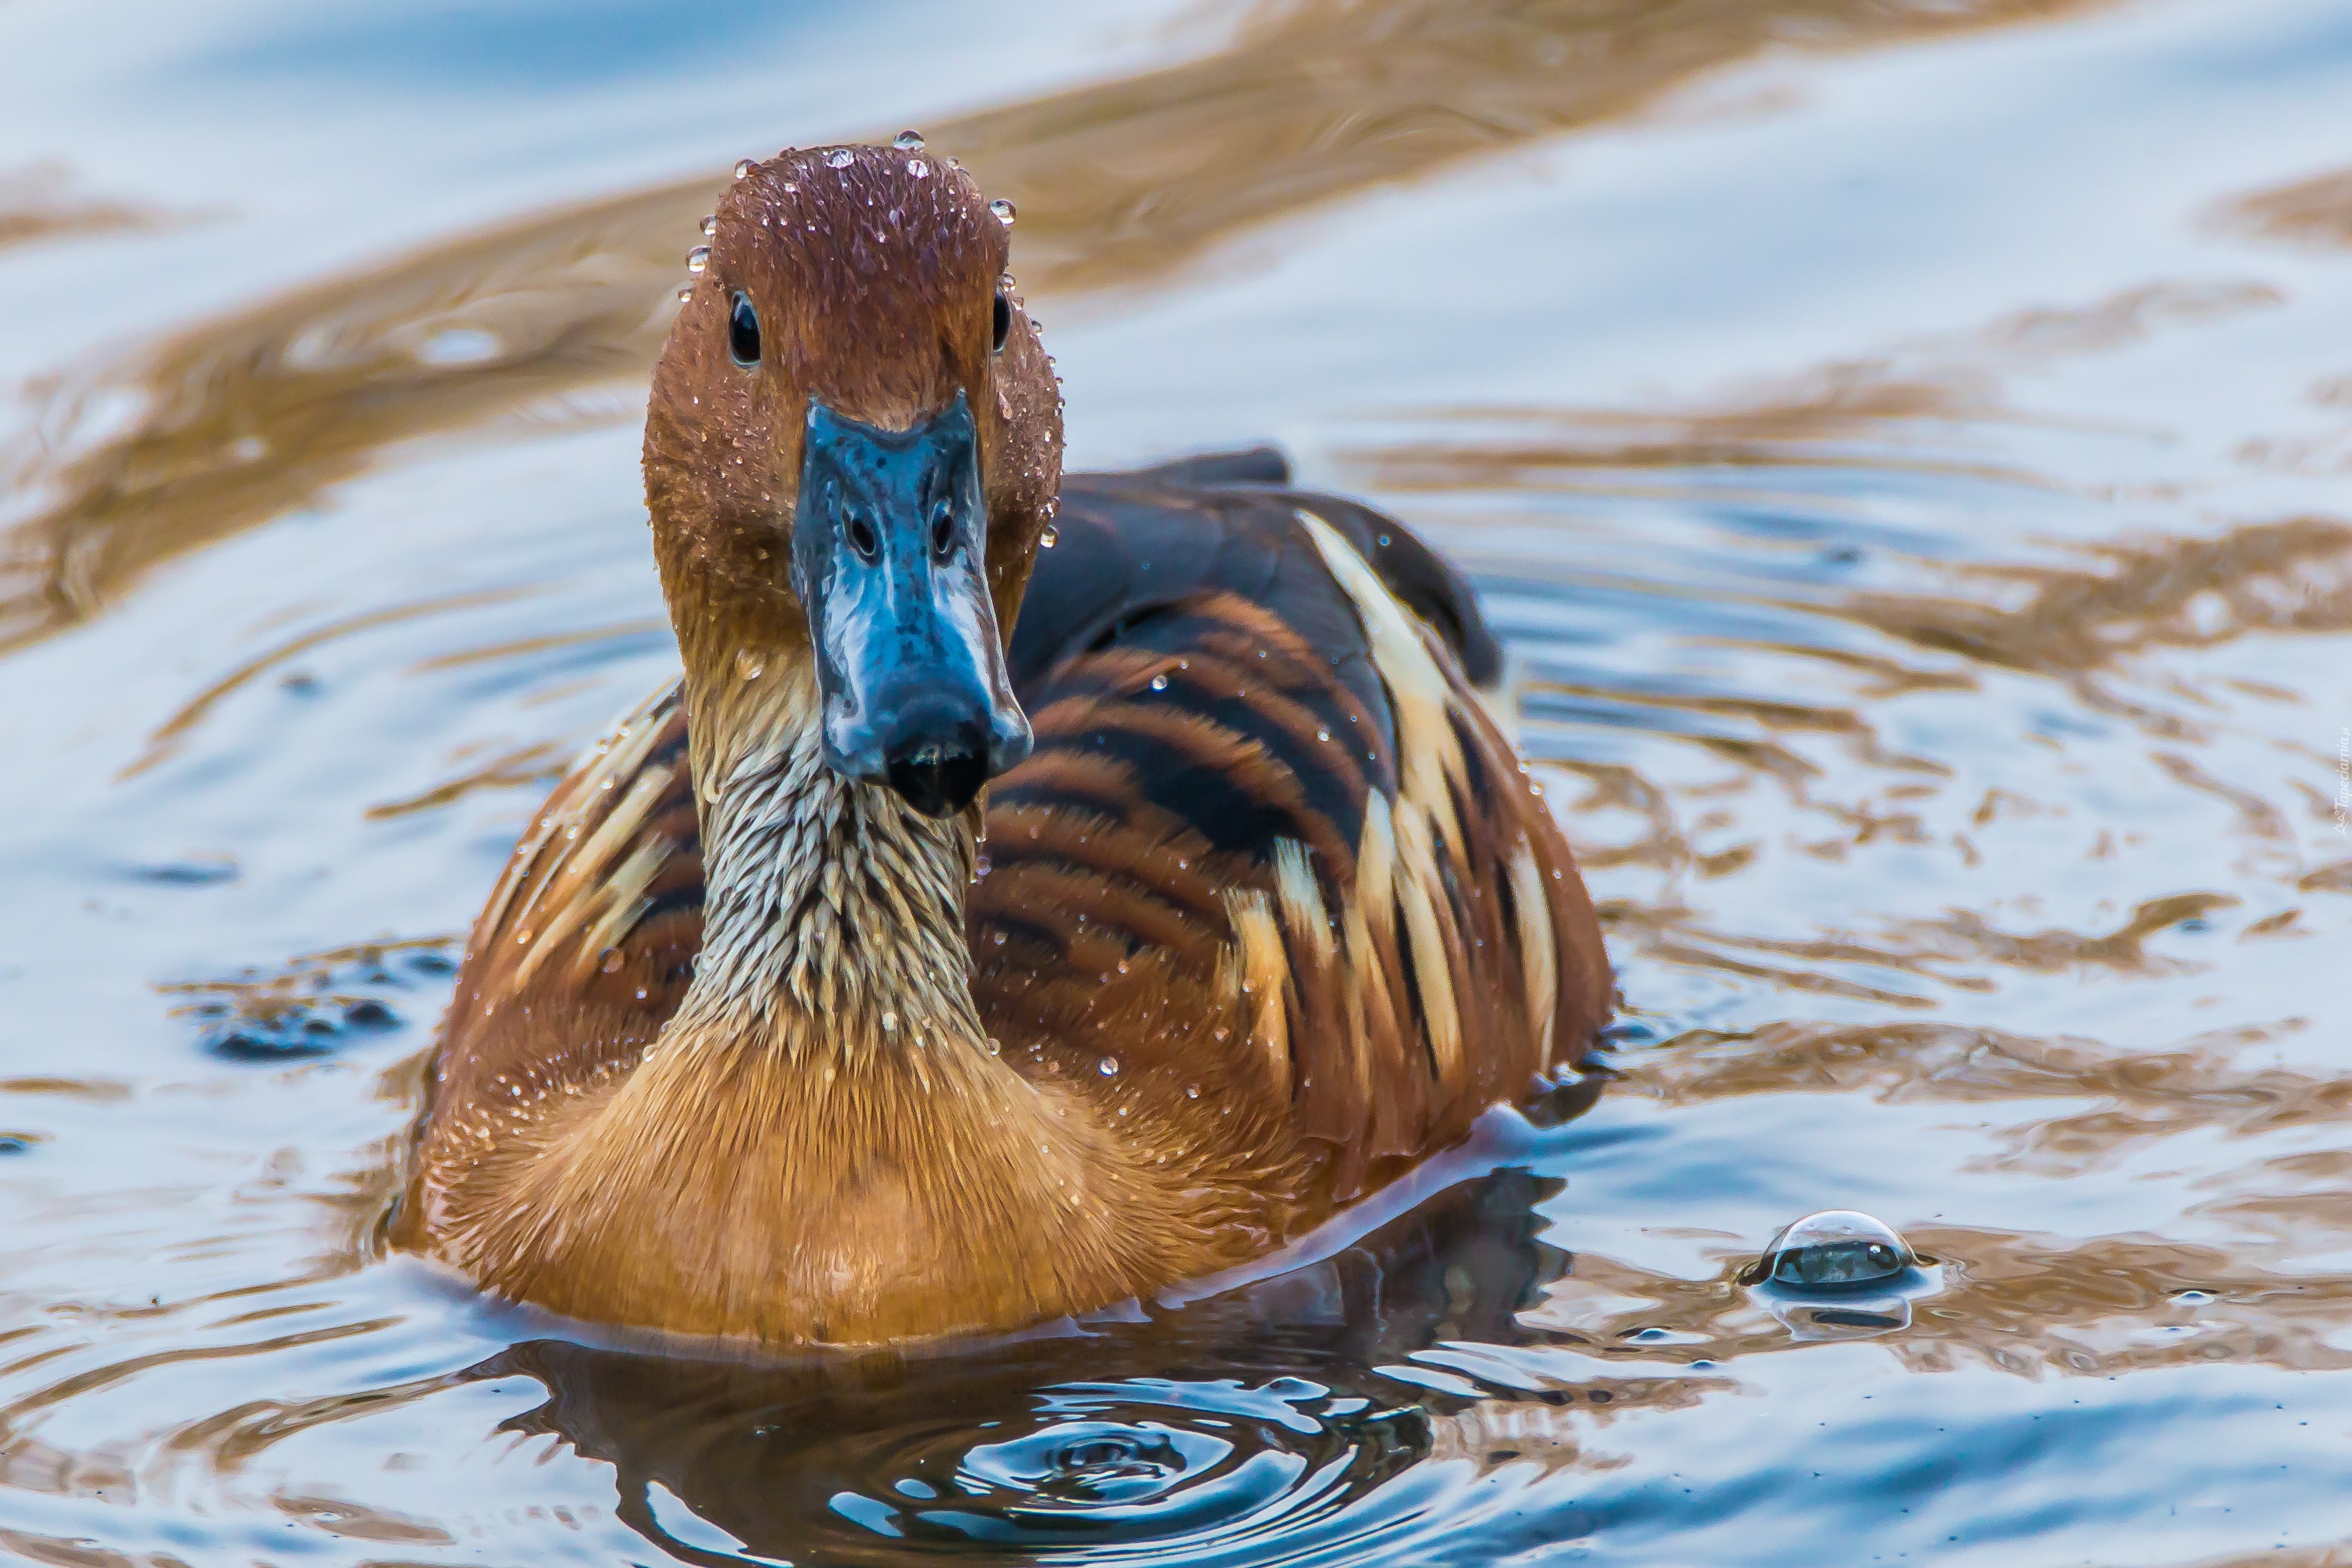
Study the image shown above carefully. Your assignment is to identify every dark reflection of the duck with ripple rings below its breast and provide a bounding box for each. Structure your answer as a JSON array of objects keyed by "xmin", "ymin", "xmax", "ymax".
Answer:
[{"xmin": 406, "ymin": 1171, "xmax": 1564, "ymax": 1563}]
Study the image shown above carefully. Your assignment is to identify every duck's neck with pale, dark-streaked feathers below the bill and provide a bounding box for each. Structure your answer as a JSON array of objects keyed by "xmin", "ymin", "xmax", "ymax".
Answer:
[{"xmin": 663, "ymin": 661, "xmax": 985, "ymax": 1065}]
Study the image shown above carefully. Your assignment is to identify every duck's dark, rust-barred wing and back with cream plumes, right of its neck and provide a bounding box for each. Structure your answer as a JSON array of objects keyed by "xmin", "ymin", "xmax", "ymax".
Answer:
[{"xmin": 969, "ymin": 454, "xmax": 1609, "ymax": 1197}]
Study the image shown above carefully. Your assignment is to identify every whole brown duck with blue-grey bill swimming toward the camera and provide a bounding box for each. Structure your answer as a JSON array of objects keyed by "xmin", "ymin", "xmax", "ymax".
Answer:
[{"xmin": 388, "ymin": 139, "xmax": 1614, "ymax": 1347}]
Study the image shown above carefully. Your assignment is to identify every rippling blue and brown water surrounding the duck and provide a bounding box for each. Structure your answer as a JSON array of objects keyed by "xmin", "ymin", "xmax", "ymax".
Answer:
[{"xmin": 0, "ymin": 0, "xmax": 2352, "ymax": 1568}]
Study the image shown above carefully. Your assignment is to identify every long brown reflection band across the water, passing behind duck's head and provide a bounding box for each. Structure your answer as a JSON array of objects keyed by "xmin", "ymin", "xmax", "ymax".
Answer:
[{"xmin": 0, "ymin": 0, "xmax": 2093, "ymax": 649}]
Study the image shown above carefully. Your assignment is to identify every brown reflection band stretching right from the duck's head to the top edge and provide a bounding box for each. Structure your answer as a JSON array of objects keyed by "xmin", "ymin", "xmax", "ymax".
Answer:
[{"xmin": 933, "ymin": 0, "xmax": 2088, "ymax": 292}]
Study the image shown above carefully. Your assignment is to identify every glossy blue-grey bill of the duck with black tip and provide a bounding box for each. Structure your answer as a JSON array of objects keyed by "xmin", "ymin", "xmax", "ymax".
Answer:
[{"xmin": 793, "ymin": 393, "xmax": 1030, "ymax": 816}]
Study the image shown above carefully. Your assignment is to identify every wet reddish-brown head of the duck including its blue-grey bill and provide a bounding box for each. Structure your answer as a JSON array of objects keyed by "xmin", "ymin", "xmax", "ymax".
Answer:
[{"xmin": 644, "ymin": 146, "xmax": 1060, "ymax": 816}]
